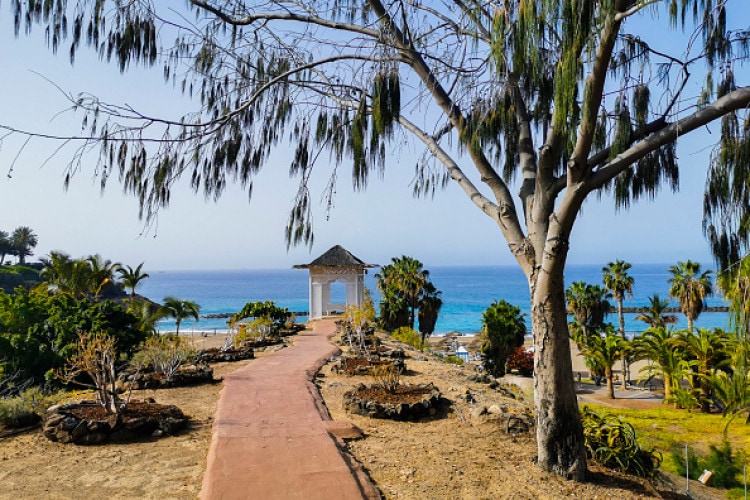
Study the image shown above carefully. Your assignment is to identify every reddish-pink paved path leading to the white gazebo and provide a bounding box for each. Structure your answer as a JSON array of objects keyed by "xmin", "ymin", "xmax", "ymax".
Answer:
[{"xmin": 201, "ymin": 320, "xmax": 379, "ymax": 500}]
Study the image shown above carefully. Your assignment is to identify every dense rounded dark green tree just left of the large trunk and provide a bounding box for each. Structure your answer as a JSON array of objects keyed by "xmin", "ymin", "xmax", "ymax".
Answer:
[{"xmin": 480, "ymin": 300, "xmax": 526, "ymax": 377}]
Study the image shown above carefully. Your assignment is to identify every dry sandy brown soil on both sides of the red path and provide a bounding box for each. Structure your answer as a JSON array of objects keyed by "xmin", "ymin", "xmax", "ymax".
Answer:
[{"xmin": 0, "ymin": 330, "xmax": 722, "ymax": 500}]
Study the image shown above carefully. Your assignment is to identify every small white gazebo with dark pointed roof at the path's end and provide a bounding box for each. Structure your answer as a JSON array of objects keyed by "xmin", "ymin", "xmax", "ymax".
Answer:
[{"xmin": 294, "ymin": 245, "xmax": 379, "ymax": 319}]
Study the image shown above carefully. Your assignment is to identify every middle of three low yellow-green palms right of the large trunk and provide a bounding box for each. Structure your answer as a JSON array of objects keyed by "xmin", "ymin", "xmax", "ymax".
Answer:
[{"xmin": 633, "ymin": 326, "xmax": 686, "ymax": 401}]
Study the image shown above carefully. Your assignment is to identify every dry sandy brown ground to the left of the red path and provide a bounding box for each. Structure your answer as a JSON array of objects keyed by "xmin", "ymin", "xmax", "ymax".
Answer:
[{"xmin": 0, "ymin": 336, "xmax": 262, "ymax": 500}]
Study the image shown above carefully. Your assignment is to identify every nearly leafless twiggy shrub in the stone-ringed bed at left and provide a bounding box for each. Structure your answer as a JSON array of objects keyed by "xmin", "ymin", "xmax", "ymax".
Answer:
[{"xmin": 59, "ymin": 333, "xmax": 120, "ymax": 414}]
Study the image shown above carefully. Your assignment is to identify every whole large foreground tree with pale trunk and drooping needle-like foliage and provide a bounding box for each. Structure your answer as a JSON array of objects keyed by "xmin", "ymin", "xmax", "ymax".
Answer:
[{"xmin": 8, "ymin": 0, "xmax": 750, "ymax": 479}]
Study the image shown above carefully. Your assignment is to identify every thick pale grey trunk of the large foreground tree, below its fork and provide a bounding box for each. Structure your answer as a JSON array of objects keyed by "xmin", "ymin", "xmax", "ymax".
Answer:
[{"xmin": 531, "ymin": 266, "xmax": 586, "ymax": 481}]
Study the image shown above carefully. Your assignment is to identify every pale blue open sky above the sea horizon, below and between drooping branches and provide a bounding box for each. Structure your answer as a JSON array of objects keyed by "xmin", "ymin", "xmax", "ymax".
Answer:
[{"xmin": 0, "ymin": 4, "xmax": 748, "ymax": 271}]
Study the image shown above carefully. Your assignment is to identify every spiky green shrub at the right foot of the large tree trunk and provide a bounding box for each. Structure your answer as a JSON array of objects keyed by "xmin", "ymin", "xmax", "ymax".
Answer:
[{"xmin": 581, "ymin": 406, "xmax": 661, "ymax": 477}]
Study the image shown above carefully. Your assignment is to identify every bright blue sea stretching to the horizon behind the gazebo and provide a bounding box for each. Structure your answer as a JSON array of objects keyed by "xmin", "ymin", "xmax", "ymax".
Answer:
[{"xmin": 137, "ymin": 264, "xmax": 728, "ymax": 335}]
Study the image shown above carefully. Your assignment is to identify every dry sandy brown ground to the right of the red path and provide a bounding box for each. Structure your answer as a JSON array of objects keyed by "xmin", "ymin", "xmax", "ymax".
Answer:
[{"xmin": 316, "ymin": 332, "xmax": 722, "ymax": 499}]
